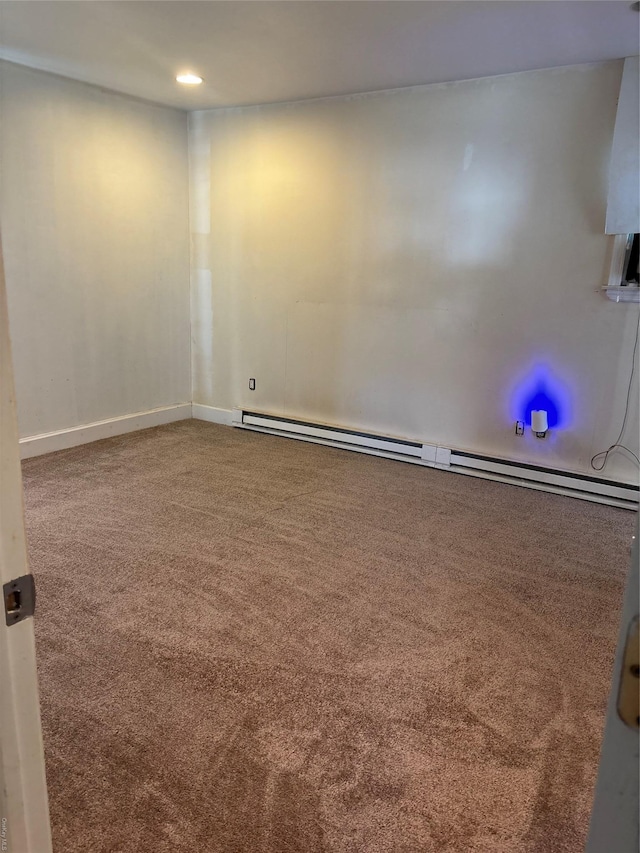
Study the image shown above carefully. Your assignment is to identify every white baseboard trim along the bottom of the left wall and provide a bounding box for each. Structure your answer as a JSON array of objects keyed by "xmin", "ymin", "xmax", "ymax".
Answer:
[{"xmin": 20, "ymin": 403, "xmax": 191, "ymax": 459}]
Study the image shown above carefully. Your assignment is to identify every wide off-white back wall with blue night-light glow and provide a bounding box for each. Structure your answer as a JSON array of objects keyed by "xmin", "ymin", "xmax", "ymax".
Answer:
[{"xmin": 190, "ymin": 62, "xmax": 638, "ymax": 482}]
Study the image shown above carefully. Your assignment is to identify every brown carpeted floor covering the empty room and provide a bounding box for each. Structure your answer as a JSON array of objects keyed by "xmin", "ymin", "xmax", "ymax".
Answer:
[{"xmin": 24, "ymin": 421, "xmax": 634, "ymax": 853}]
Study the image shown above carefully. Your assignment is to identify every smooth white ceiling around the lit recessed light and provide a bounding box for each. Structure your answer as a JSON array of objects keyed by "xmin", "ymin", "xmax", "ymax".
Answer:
[{"xmin": 0, "ymin": 0, "xmax": 640, "ymax": 109}]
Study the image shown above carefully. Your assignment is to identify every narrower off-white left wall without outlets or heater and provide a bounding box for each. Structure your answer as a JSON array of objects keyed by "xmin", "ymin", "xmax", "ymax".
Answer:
[{"xmin": 0, "ymin": 63, "xmax": 191, "ymax": 436}]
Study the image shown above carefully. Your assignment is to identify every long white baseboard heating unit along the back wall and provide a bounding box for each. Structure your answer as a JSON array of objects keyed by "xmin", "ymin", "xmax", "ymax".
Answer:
[{"xmin": 231, "ymin": 409, "xmax": 640, "ymax": 510}]
